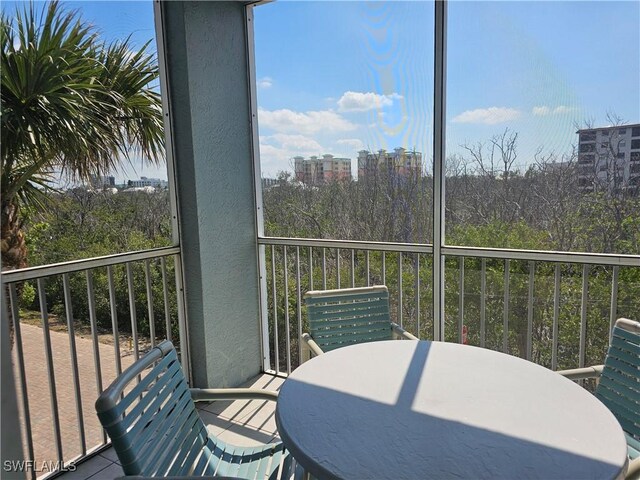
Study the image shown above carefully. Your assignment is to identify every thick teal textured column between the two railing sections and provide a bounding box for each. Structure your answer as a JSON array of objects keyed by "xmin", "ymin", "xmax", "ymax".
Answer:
[{"xmin": 159, "ymin": 2, "xmax": 262, "ymax": 387}]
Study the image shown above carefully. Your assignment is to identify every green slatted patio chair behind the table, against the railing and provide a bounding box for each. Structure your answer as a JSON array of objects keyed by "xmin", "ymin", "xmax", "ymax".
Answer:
[{"xmin": 302, "ymin": 285, "xmax": 418, "ymax": 361}]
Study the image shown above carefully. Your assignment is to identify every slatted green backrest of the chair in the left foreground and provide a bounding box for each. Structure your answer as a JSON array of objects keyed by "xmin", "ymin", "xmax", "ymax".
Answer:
[{"xmin": 96, "ymin": 342, "xmax": 213, "ymax": 475}]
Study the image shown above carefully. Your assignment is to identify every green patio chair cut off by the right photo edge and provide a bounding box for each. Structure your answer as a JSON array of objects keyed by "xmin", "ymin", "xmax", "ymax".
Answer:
[{"xmin": 558, "ymin": 318, "xmax": 640, "ymax": 479}]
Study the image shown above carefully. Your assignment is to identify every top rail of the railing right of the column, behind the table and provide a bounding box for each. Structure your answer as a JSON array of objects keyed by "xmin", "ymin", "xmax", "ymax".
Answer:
[{"xmin": 258, "ymin": 237, "xmax": 640, "ymax": 267}]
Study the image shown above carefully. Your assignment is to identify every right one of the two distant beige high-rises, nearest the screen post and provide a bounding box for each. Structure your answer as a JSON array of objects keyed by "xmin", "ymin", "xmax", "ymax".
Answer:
[{"xmin": 358, "ymin": 148, "xmax": 422, "ymax": 180}]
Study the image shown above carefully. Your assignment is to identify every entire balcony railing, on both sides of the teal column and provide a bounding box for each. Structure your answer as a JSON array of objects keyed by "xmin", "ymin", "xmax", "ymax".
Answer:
[{"xmin": 2, "ymin": 238, "xmax": 640, "ymax": 478}]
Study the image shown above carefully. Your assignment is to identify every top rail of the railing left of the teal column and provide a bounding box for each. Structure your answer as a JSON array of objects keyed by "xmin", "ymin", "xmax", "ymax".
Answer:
[{"xmin": 1, "ymin": 247, "xmax": 180, "ymax": 284}]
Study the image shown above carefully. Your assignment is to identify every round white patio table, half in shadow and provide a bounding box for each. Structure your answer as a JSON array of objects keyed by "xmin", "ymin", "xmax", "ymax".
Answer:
[{"xmin": 276, "ymin": 340, "xmax": 627, "ymax": 480}]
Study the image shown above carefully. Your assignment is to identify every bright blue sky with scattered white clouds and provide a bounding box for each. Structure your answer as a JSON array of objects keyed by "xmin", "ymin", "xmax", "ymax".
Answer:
[{"xmin": 2, "ymin": 1, "xmax": 640, "ymax": 179}]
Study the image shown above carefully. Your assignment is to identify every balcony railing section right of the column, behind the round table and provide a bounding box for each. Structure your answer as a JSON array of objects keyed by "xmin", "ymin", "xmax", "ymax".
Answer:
[{"xmin": 259, "ymin": 237, "xmax": 640, "ymax": 374}]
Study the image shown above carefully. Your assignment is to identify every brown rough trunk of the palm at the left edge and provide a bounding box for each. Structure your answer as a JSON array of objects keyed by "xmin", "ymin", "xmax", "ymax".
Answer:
[{"xmin": 0, "ymin": 200, "xmax": 27, "ymax": 347}]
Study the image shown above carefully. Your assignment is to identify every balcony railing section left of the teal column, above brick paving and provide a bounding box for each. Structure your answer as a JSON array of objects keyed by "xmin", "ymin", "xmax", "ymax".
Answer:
[{"xmin": 2, "ymin": 247, "xmax": 189, "ymax": 478}]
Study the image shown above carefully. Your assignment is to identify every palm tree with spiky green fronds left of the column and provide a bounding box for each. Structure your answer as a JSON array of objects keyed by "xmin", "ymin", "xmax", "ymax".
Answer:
[{"xmin": 0, "ymin": 1, "xmax": 164, "ymax": 344}]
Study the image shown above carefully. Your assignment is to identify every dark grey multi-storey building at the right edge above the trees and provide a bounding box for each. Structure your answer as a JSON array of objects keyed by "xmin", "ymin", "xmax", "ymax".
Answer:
[{"xmin": 576, "ymin": 123, "xmax": 640, "ymax": 192}]
